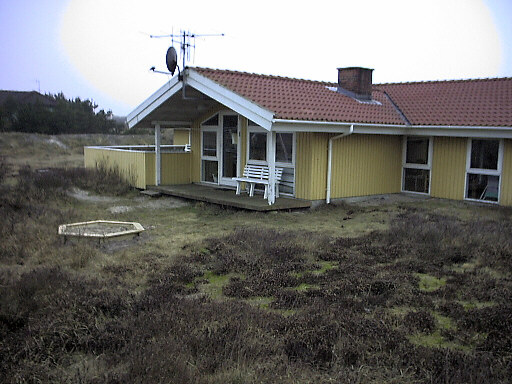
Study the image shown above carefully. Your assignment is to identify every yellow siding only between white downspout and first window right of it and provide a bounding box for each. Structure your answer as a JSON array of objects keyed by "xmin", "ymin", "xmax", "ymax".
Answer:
[{"xmin": 330, "ymin": 134, "xmax": 402, "ymax": 198}]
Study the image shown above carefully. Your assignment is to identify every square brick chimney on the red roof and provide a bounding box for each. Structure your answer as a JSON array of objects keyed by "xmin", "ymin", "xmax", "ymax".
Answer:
[{"xmin": 338, "ymin": 67, "xmax": 373, "ymax": 100}]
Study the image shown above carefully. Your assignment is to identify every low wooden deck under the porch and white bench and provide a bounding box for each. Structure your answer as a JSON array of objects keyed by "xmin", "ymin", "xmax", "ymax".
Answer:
[{"xmin": 148, "ymin": 184, "xmax": 311, "ymax": 212}]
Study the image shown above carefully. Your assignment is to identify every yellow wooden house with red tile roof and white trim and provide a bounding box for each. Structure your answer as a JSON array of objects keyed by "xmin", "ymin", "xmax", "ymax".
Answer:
[{"xmin": 86, "ymin": 67, "xmax": 512, "ymax": 206}]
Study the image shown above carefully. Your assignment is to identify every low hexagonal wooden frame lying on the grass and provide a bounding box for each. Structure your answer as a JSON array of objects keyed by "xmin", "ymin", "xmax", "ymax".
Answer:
[{"xmin": 59, "ymin": 220, "xmax": 144, "ymax": 240}]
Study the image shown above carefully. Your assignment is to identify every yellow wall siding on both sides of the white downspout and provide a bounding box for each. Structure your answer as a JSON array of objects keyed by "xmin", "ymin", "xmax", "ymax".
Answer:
[{"xmin": 295, "ymin": 133, "xmax": 402, "ymax": 200}]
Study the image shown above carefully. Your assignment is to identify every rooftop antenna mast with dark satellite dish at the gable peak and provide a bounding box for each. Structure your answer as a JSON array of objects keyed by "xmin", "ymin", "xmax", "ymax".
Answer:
[{"xmin": 149, "ymin": 30, "xmax": 224, "ymax": 76}]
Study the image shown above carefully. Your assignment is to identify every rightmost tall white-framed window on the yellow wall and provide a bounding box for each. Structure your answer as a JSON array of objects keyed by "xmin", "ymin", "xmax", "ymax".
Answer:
[{"xmin": 466, "ymin": 139, "xmax": 503, "ymax": 202}]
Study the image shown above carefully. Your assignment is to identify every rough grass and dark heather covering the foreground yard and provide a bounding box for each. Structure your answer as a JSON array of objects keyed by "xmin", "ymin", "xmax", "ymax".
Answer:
[{"xmin": 0, "ymin": 133, "xmax": 512, "ymax": 384}]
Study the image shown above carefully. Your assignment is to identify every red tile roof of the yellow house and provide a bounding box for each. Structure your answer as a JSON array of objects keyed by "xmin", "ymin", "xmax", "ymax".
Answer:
[{"xmin": 193, "ymin": 68, "xmax": 512, "ymax": 126}]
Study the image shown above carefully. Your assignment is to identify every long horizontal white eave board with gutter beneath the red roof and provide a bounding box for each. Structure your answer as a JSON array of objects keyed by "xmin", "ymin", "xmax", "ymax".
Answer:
[{"xmin": 272, "ymin": 119, "xmax": 512, "ymax": 139}]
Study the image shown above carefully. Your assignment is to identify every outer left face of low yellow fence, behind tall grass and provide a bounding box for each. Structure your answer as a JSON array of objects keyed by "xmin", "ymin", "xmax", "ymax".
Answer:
[{"xmin": 84, "ymin": 147, "xmax": 146, "ymax": 188}]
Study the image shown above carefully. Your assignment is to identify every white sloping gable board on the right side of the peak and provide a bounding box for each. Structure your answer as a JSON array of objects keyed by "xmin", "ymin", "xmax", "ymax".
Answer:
[{"xmin": 185, "ymin": 68, "xmax": 274, "ymax": 131}]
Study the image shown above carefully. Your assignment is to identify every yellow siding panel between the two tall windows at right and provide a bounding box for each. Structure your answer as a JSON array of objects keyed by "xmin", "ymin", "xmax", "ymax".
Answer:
[{"xmin": 430, "ymin": 137, "xmax": 468, "ymax": 200}]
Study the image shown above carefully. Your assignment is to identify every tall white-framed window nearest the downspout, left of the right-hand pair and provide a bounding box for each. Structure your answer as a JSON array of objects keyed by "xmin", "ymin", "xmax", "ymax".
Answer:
[{"xmin": 402, "ymin": 137, "xmax": 432, "ymax": 194}]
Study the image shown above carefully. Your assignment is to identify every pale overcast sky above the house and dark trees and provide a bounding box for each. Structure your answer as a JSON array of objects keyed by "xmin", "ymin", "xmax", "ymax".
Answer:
[{"xmin": 0, "ymin": 0, "xmax": 512, "ymax": 115}]
